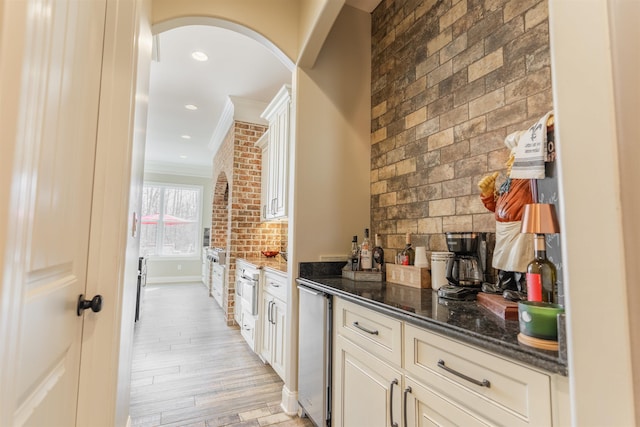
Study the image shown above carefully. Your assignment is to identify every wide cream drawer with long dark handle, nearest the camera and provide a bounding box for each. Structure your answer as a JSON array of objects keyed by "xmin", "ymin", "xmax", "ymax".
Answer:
[{"xmin": 404, "ymin": 325, "xmax": 552, "ymax": 426}]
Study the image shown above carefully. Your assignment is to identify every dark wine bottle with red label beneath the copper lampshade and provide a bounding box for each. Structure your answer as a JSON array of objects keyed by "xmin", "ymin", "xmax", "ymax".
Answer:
[{"xmin": 527, "ymin": 234, "xmax": 558, "ymax": 303}]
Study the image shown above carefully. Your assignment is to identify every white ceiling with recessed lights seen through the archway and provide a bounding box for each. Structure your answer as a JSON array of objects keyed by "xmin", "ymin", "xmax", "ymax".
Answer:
[{"xmin": 145, "ymin": 0, "xmax": 380, "ymax": 176}]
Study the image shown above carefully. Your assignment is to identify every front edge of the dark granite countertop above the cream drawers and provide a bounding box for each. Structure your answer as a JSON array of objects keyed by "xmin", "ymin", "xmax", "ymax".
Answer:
[{"xmin": 296, "ymin": 278, "xmax": 568, "ymax": 377}]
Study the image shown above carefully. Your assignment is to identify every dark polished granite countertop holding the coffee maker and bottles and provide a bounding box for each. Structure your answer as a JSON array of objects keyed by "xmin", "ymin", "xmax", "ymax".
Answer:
[{"xmin": 298, "ymin": 263, "xmax": 568, "ymax": 376}]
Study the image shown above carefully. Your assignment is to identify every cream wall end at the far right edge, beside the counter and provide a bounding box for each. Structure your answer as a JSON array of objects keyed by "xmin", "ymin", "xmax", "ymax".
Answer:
[{"xmin": 549, "ymin": 0, "xmax": 640, "ymax": 426}]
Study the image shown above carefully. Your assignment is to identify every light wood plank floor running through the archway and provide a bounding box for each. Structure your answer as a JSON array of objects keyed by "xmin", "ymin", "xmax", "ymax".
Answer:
[{"xmin": 130, "ymin": 283, "xmax": 312, "ymax": 427}]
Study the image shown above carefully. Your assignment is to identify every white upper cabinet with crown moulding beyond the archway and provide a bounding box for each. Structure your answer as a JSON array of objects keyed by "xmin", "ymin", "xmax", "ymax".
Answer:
[{"xmin": 257, "ymin": 85, "xmax": 291, "ymax": 220}]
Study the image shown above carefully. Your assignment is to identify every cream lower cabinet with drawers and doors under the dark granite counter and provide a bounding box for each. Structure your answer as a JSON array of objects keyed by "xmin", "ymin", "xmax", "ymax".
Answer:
[{"xmin": 332, "ymin": 298, "xmax": 570, "ymax": 427}]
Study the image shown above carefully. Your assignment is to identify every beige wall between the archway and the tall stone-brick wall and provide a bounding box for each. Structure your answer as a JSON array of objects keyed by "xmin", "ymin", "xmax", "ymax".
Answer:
[{"xmin": 283, "ymin": 6, "xmax": 371, "ymax": 401}]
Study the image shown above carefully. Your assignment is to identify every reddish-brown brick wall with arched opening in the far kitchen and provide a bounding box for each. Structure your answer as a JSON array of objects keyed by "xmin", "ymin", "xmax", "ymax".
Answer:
[{"xmin": 211, "ymin": 121, "xmax": 287, "ymax": 325}]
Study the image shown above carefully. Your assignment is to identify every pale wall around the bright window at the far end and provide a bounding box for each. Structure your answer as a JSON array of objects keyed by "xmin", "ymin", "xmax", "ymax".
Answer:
[{"xmin": 144, "ymin": 172, "xmax": 213, "ymax": 283}]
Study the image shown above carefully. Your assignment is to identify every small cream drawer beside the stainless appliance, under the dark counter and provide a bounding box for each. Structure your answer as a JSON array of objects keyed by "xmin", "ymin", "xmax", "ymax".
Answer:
[{"xmin": 334, "ymin": 298, "xmax": 402, "ymax": 366}]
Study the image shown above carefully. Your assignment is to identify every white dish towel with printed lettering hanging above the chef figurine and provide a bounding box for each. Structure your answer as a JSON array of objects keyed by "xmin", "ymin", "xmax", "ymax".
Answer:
[{"xmin": 507, "ymin": 111, "xmax": 553, "ymax": 179}]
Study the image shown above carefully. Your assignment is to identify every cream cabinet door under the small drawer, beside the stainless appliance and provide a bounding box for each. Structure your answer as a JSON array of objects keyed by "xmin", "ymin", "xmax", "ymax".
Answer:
[{"xmin": 332, "ymin": 335, "xmax": 402, "ymax": 427}]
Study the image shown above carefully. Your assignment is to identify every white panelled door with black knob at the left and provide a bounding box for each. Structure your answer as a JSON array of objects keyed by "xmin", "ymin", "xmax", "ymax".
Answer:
[{"xmin": 0, "ymin": 0, "xmax": 109, "ymax": 426}]
